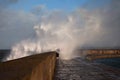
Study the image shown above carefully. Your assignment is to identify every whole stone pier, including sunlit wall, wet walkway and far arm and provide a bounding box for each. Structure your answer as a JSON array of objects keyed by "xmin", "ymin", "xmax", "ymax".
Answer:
[{"xmin": 0, "ymin": 50, "xmax": 120, "ymax": 80}]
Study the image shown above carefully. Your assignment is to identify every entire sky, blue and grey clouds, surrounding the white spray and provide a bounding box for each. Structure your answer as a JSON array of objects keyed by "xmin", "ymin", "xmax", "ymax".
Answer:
[{"xmin": 0, "ymin": 0, "xmax": 120, "ymax": 49}]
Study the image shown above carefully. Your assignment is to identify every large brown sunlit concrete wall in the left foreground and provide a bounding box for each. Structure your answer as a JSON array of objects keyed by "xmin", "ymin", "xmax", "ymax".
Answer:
[{"xmin": 0, "ymin": 52, "xmax": 57, "ymax": 80}]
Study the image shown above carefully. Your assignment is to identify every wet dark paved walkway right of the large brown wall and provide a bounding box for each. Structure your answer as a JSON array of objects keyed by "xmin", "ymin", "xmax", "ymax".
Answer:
[{"xmin": 54, "ymin": 58, "xmax": 120, "ymax": 80}]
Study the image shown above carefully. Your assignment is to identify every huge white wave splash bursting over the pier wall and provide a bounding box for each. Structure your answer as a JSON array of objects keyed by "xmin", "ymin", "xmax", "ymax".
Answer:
[{"xmin": 6, "ymin": 10, "xmax": 102, "ymax": 60}]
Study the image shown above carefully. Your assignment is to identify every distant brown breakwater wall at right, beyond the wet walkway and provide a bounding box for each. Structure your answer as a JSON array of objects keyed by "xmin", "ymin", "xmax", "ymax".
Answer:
[{"xmin": 82, "ymin": 49, "xmax": 120, "ymax": 60}]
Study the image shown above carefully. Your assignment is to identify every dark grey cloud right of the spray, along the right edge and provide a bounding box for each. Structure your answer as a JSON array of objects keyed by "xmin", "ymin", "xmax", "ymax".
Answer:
[{"xmin": 96, "ymin": 0, "xmax": 120, "ymax": 47}]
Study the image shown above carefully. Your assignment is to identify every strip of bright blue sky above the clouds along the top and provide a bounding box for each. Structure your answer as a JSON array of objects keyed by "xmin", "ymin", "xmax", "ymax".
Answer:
[{"xmin": 9, "ymin": 0, "xmax": 110, "ymax": 12}]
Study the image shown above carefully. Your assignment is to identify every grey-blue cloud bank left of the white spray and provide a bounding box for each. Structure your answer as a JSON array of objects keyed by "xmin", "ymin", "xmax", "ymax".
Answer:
[{"xmin": 0, "ymin": 9, "xmax": 38, "ymax": 49}]
